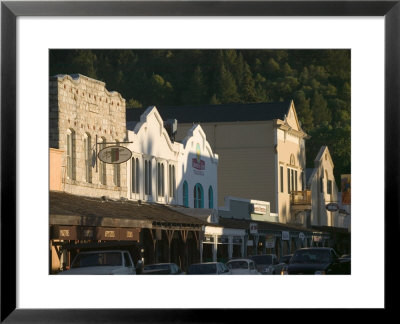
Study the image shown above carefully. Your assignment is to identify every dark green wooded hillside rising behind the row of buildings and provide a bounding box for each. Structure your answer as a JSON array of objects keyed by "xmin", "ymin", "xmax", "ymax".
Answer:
[{"xmin": 50, "ymin": 50, "xmax": 351, "ymax": 185}]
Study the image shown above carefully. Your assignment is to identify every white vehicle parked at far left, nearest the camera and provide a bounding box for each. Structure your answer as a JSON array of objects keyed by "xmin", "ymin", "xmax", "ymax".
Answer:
[{"xmin": 59, "ymin": 250, "xmax": 136, "ymax": 275}]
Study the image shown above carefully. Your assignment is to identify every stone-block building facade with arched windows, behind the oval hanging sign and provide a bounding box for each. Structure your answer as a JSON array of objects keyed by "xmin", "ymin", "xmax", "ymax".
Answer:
[{"xmin": 49, "ymin": 74, "xmax": 127, "ymax": 198}]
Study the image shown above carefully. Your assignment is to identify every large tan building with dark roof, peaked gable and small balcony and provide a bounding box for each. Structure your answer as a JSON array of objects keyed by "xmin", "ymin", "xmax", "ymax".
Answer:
[{"xmin": 127, "ymin": 101, "xmax": 310, "ymax": 224}]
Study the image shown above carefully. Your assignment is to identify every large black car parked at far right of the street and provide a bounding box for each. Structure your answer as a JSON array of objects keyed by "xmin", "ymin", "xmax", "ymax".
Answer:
[{"xmin": 282, "ymin": 247, "xmax": 345, "ymax": 275}]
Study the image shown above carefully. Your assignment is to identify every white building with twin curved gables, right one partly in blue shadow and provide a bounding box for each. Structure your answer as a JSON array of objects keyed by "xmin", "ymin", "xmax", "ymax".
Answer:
[{"xmin": 127, "ymin": 106, "xmax": 218, "ymax": 210}]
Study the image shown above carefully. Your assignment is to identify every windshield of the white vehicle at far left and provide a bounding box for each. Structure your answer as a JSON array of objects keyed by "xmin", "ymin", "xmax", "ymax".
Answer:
[{"xmin": 71, "ymin": 252, "xmax": 122, "ymax": 268}]
